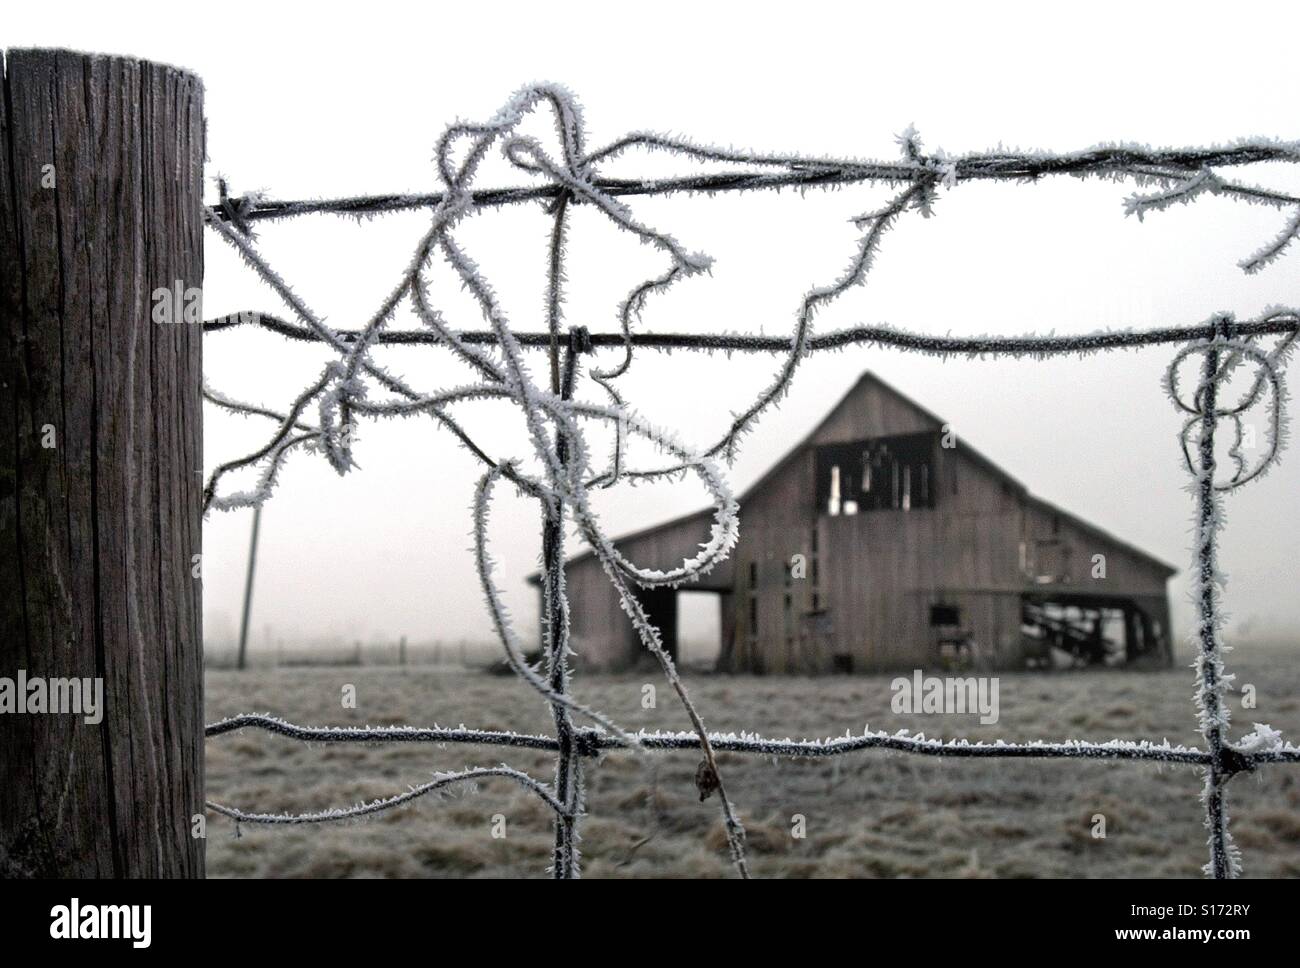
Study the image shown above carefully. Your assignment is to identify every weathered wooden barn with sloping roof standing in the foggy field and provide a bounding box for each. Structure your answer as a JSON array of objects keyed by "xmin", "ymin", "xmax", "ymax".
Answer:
[{"xmin": 530, "ymin": 373, "xmax": 1175, "ymax": 674}]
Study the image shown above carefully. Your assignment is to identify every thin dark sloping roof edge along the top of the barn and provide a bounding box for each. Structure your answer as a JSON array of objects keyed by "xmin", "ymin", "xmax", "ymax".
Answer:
[{"xmin": 528, "ymin": 370, "xmax": 1178, "ymax": 585}]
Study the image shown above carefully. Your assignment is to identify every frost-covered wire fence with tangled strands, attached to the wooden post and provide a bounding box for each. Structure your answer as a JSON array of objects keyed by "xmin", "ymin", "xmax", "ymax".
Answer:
[{"xmin": 204, "ymin": 84, "xmax": 1300, "ymax": 878}]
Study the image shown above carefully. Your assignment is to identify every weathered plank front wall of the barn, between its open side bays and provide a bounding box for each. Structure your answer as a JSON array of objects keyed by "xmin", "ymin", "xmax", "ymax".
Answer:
[{"xmin": 724, "ymin": 397, "xmax": 1167, "ymax": 673}]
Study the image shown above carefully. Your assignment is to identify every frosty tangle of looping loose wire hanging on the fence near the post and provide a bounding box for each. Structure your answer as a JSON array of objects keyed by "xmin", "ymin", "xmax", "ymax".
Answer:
[{"xmin": 205, "ymin": 87, "xmax": 774, "ymax": 874}]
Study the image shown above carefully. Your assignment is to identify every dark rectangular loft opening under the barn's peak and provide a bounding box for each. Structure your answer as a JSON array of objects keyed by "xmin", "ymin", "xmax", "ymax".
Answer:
[{"xmin": 815, "ymin": 433, "xmax": 939, "ymax": 517}]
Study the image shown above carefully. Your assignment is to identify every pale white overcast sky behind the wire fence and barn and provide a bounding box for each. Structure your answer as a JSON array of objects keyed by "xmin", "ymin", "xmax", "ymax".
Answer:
[{"xmin": 10, "ymin": 3, "xmax": 1300, "ymax": 657}]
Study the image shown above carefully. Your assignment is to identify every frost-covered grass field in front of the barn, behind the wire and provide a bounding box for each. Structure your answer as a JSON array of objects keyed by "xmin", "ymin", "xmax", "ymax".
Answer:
[{"xmin": 207, "ymin": 643, "xmax": 1300, "ymax": 877}]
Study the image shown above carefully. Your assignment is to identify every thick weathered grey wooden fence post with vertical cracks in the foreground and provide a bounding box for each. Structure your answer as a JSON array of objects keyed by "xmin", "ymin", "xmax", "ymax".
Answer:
[{"xmin": 0, "ymin": 49, "xmax": 204, "ymax": 877}]
